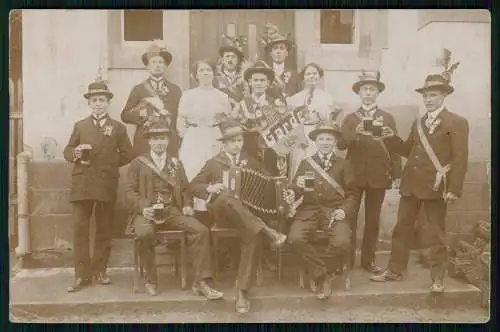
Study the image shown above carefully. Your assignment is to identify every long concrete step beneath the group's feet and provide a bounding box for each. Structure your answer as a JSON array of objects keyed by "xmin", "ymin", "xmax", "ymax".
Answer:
[{"xmin": 10, "ymin": 254, "xmax": 480, "ymax": 316}]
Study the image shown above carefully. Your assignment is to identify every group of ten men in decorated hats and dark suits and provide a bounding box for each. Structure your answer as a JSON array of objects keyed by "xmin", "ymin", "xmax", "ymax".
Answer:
[{"xmin": 64, "ymin": 26, "xmax": 468, "ymax": 313}]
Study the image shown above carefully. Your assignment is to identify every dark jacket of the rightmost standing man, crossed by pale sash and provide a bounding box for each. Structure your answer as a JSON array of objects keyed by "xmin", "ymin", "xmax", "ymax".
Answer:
[{"xmin": 385, "ymin": 109, "xmax": 469, "ymax": 199}]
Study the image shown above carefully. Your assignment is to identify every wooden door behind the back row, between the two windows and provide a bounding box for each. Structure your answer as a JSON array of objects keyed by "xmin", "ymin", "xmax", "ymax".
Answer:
[{"xmin": 189, "ymin": 10, "xmax": 297, "ymax": 86}]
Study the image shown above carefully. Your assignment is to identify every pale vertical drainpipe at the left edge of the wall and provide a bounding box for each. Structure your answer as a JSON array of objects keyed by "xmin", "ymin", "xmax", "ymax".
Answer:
[{"xmin": 16, "ymin": 151, "xmax": 31, "ymax": 257}]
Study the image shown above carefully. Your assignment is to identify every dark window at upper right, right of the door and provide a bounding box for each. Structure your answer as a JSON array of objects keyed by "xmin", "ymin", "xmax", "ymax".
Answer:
[{"xmin": 320, "ymin": 10, "xmax": 357, "ymax": 45}]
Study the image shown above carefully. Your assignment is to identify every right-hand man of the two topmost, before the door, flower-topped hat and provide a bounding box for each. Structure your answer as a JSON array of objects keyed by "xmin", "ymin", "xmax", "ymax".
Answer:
[{"xmin": 261, "ymin": 23, "xmax": 300, "ymax": 103}]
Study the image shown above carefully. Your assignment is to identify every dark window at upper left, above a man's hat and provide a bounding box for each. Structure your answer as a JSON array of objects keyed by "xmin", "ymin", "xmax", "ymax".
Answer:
[{"xmin": 122, "ymin": 10, "xmax": 163, "ymax": 42}]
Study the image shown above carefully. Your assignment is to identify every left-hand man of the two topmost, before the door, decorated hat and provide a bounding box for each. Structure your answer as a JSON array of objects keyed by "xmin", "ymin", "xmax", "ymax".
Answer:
[{"xmin": 215, "ymin": 35, "xmax": 247, "ymax": 108}]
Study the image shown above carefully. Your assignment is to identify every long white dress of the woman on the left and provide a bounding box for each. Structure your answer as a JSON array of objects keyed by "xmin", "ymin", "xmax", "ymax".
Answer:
[{"xmin": 177, "ymin": 87, "xmax": 231, "ymax": 211}]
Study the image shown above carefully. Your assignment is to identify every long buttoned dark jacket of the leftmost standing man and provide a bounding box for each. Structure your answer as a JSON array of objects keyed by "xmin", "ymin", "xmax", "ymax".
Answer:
[{"xmin": 64, "ymin": 117, "xmax": 135, "ymax": 202}]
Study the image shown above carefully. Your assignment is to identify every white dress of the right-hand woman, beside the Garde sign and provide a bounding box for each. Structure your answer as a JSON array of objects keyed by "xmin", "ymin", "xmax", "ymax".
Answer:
[{"xmin": 287, "ymin": 88, "xmax": 335, "ymax": 179}]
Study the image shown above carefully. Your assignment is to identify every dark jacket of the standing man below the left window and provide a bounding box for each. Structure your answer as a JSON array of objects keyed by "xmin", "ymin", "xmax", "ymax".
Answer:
[{"xmin": 121, "ymin": 79, "xmax": 182, "ymax": 155}]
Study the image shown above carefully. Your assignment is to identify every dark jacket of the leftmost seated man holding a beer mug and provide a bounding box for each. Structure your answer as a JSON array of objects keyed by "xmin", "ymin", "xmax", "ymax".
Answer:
[{"xmin": 125, "ymin": 152, "xmax": 193, "ymax": 214}]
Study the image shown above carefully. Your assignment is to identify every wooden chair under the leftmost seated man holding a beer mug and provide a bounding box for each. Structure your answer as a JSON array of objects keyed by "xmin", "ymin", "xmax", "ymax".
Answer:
[{"xmin": 133, "ymin": 230, "xmax": 187, "ymax": 293}]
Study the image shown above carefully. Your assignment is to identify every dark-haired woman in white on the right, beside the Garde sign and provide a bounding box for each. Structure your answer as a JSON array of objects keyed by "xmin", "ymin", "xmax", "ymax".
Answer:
[{"xmin": 287, "ymin": 63, "xmax": 341, "ymax": 179}]
